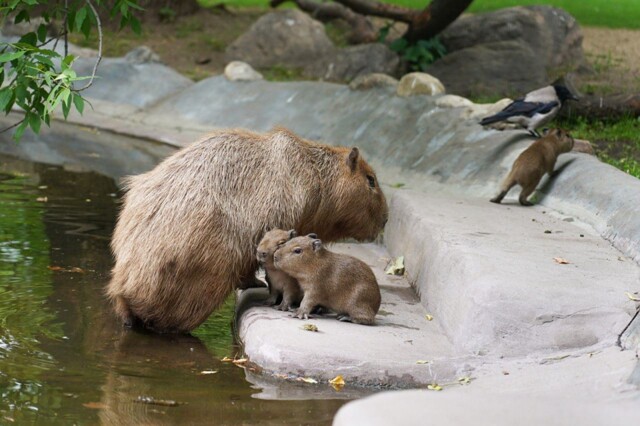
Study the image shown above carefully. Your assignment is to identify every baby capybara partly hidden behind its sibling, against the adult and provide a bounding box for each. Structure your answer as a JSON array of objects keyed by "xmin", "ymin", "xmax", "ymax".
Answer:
[{"xmin": 256, "ymin": 228, "xmax": 302, "ymax": 311}]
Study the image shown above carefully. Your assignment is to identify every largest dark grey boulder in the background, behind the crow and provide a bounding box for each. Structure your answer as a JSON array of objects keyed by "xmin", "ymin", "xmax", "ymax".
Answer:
[{"xmin": 428, "ymin": 6, "xmax": 584, "ymax": 96}]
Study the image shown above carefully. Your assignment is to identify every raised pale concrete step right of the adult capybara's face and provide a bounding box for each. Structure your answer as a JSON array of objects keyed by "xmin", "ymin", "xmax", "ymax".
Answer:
[{"xmin": 385, "ymin": 191, "xmax": 640, "ymax": 357}]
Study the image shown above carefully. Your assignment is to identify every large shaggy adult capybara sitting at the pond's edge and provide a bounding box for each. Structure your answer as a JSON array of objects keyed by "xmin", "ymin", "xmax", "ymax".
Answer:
[{"xmin": 107, "ymin": 129, "xmax": 388, "ymax": 332}]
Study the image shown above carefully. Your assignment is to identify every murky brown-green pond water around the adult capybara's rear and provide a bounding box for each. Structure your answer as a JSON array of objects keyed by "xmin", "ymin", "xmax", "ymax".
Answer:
[{"xmin": 0, "ymin": 156, "xmax": 346, "ymax": 425}]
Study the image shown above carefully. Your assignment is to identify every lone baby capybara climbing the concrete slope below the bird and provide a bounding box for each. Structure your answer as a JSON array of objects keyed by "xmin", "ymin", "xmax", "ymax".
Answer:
[{"xmin": 491, "ymin": 129, "xmax": 573, "ymax": 206}]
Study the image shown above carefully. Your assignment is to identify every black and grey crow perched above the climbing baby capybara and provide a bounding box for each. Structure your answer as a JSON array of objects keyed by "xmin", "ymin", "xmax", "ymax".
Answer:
[{"xmin": 480, "ymin": 84, "xmax": 578, "ymax": 138}]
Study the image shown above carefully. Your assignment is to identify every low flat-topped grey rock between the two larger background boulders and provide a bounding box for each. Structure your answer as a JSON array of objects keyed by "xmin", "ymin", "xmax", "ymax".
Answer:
[{"xmin": 304, "ymin": 43, "xmax": 400, "ymax": 81}]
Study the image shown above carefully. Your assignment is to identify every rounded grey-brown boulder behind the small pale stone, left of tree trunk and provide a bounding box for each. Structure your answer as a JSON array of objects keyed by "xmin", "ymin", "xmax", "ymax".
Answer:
[{"xmin": 226, "ymin": 9, "xmax": 335, "ymax": 68}]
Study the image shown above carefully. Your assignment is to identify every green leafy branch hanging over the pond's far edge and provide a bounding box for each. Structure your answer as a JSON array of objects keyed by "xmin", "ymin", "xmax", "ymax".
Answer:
[{"xmin": 0, "ymin": 0, "xmax": 142, "ymax": 140}]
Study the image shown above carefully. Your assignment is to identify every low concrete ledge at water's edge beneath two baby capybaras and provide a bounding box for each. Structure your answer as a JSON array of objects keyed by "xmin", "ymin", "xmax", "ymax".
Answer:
[{"xmin": 238, "ymin": 244, "xmax": 465, "ymax": 387}]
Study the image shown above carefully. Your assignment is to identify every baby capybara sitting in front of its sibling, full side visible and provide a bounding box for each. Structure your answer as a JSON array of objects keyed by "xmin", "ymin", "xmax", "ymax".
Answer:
[{"xmin": 273, "ymin": 235, "xmax": 380, "ymax": 325}]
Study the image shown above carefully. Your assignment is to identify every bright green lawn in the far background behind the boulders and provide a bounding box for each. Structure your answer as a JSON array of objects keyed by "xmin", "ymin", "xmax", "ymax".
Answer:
[{"xmin": 199, "ymin": 0, "xmax": 640, "ymax": 28}]
